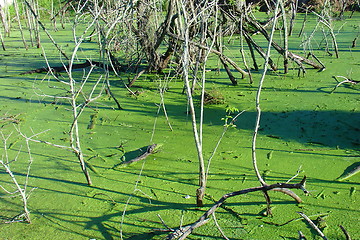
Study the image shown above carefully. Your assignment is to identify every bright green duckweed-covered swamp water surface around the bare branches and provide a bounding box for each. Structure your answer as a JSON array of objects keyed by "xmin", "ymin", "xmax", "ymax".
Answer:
[{"xmin": 0, "ymin": 14, "xmax": 360, "ymax": 239}]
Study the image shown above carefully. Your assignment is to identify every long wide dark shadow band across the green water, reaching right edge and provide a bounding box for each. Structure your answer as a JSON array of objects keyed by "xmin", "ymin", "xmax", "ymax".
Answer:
[{"xmin": 126, "ymin": 94, "xmax": 360, "ymax": 149}]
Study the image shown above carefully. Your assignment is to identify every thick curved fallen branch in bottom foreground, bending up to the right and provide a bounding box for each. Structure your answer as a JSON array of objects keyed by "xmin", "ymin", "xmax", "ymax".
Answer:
[{"xmin": 166, "ymin": 177, "xmax": 308, "ymax": 240}]
